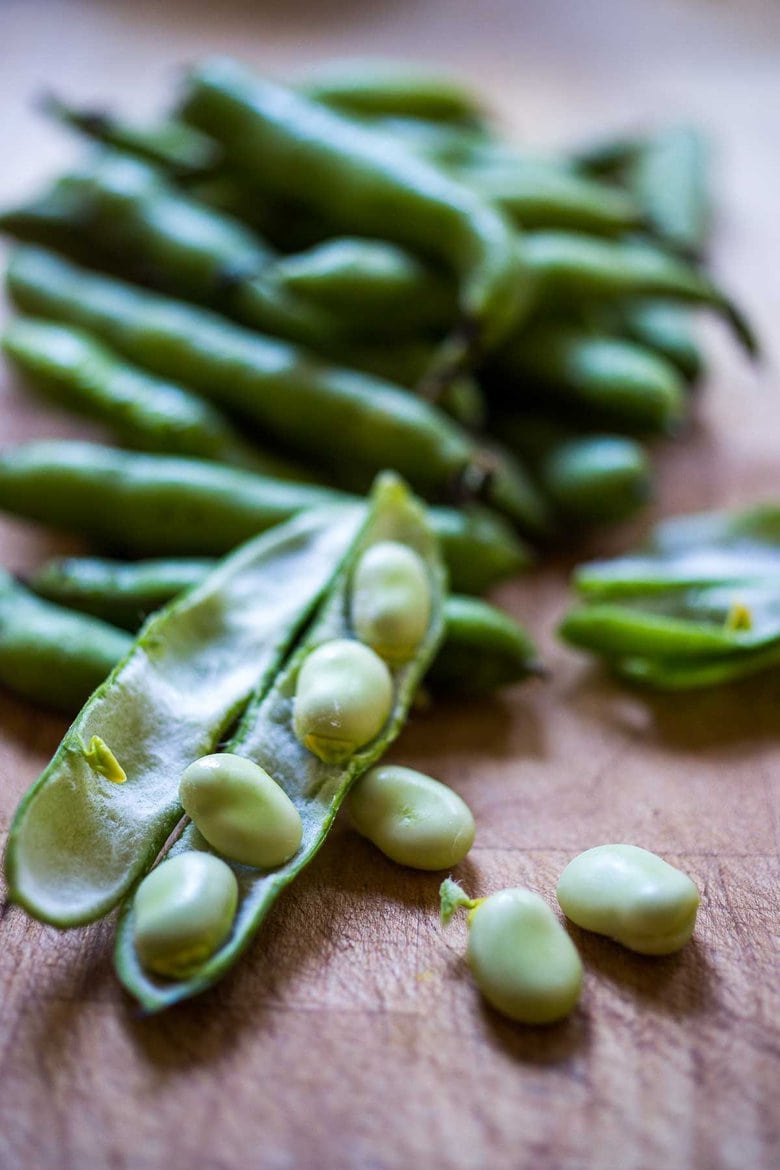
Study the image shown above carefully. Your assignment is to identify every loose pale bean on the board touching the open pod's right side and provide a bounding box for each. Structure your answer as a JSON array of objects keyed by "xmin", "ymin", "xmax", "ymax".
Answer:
[{"xmin": 348, "ymin": 764, "xmax": 475, "ymax": 869}]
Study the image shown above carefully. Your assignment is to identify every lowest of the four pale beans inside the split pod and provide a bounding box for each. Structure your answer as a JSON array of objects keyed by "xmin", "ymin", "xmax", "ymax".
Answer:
[{"xmin": 133, "ymin": 852, "xmax": 239, "ymax": 979}]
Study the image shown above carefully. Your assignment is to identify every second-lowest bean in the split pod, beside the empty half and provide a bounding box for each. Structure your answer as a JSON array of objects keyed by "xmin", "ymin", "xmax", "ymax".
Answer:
[{"xmin": 179, "ymin": 751, "xmax": 303, "ymax": 869}]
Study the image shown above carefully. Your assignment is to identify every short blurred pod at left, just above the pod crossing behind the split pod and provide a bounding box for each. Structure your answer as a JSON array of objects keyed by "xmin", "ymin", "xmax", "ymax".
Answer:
[{"xmin": 2, "ymin": 318, "xmax": 312, "ymax": 481}]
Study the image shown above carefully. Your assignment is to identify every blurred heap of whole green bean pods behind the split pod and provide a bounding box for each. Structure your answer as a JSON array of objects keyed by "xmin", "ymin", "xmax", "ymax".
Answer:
[{"xmin": 0, "ymin": 60, "xmax": 754, "ymax": 580}]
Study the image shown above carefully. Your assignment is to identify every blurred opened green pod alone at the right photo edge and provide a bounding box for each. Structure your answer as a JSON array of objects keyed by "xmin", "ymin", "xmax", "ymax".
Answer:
[{"xmin": 560, "ymin": 504, "xmax": 780, "ymax": 690}]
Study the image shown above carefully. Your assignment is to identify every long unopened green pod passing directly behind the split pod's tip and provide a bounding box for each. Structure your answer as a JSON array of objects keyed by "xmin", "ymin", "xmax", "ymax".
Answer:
[{"xmin": 0, "ymin": 441, "xmax": 530, "ymax": 593}]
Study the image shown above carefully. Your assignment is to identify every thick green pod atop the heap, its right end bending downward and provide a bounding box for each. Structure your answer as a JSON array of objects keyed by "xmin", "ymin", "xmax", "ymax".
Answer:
[{"xmin": 180, "ymin": 60, "xmax": 526, "ymax": 358}]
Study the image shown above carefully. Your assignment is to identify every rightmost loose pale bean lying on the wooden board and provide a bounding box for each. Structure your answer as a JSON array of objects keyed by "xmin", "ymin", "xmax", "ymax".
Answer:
[{"xmin": 558, "ymin": 845, "xmax": 699, "ymax": 955}]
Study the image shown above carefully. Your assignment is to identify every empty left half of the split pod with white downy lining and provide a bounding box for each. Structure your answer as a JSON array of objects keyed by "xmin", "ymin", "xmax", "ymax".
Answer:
[{"xmin": 6, "ymin": 510, "xmax": 365, "ymax": 927}]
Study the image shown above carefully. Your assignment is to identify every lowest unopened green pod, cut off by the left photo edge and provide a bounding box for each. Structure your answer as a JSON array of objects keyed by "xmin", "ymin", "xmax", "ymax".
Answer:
[{"xmin": 0, "ymin": 570, "xmax": 131, "ymax": 716}]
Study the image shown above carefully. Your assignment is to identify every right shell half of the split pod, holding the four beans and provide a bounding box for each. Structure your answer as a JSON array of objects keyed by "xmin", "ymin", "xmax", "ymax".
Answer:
[{"xmin": 116, "ymin": 476, "xmax": 444, "ymax": 1012}]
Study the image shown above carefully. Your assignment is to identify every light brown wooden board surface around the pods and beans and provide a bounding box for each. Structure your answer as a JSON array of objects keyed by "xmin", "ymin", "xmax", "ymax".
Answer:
[{"xmin": 0, "ymin": 0, "xmax": 780, "ymax": 1170}]
